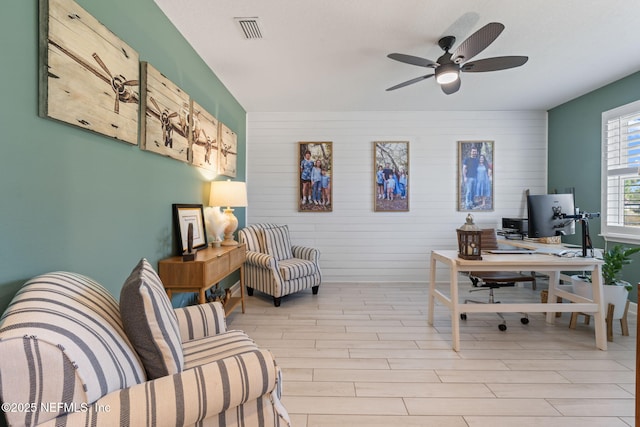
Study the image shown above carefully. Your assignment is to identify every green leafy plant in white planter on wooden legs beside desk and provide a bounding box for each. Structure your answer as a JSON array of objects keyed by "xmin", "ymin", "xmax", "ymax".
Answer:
[{"xmin": 571, "ymin": 245, "xmax": 640, "ymax": 319}]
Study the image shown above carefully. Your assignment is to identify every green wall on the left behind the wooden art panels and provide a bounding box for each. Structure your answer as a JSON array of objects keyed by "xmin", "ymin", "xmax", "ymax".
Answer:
[{"xmin": 0, "ymin": 0, "xmax": 246, "ymax": 313}]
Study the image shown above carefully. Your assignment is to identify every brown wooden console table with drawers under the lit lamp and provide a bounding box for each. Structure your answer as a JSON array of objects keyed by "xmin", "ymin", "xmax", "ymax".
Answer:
[{"xmin": 158, "ymin": 244, "xmax": 247, "ymax": 315}]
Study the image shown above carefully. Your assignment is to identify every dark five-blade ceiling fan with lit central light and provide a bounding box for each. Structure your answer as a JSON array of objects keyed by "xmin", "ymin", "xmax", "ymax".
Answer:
[{"xmin": 387, "ymin": 22, "xmax": 529, "ymax": 95}]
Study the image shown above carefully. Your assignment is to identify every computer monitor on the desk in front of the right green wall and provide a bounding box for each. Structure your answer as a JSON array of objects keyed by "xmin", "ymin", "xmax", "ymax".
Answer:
[{"xmin": 527, "ymin": 193, "xmax": 576, "ymax": 238}]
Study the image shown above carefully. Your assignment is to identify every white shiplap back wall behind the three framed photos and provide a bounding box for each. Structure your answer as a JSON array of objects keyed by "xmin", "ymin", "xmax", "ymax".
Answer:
[{"xmin": 246, "ymin": 111, "xmax": 547, "ymax": 282}]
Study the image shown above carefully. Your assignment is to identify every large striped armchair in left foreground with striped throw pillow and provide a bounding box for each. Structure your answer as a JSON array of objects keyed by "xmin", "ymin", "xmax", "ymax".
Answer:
[{"xmin": 0, "ymin": 260, "xmax": 290, "ymax": 426}]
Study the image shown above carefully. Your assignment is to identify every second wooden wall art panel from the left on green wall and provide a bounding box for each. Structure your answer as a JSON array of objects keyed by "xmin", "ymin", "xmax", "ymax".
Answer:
[{"xmin": 140, "ymin": 62, "xmax": 191, "ymax": 163}]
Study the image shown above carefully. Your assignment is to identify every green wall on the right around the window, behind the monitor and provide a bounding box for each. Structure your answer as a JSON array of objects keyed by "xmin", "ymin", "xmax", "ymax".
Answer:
[{"xmin": 548, "ymin": 72, "xmax": 640, "ymax": 302}]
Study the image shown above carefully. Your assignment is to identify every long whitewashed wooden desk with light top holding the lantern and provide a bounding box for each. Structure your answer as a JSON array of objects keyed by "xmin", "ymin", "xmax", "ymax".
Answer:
[{"xmin": 428, "ymin": 250, "xmax": 607, "ymax": 351}]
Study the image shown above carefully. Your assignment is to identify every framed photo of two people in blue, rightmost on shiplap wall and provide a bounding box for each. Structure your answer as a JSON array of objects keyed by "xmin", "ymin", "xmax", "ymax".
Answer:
[{"xmin": 456, "ymin": 141, "xmax": 494, "ymax": 211}]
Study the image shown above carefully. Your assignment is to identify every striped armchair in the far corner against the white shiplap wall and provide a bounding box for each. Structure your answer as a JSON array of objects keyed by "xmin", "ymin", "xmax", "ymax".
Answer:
[{"xmin": 238, "ymin": 224, "xmax": 322, "ymax": 307}]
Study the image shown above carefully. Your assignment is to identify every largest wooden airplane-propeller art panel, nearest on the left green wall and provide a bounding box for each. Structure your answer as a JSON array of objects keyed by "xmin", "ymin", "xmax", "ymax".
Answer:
[{"xmin": 39, "ymin": 0, "xmax": 140, "ymax": 144}]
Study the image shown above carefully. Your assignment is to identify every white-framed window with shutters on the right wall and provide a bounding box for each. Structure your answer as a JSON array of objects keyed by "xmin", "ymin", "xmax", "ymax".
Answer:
[{"xmin": 602, "ymin": 101, "xmax": 640, "ymax": 242}]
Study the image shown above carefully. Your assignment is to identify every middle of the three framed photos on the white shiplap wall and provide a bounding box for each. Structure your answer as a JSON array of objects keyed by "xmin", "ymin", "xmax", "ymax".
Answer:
[{"xmin": 373, "ymin": 141, "xmax": 409, "ymax": 212}]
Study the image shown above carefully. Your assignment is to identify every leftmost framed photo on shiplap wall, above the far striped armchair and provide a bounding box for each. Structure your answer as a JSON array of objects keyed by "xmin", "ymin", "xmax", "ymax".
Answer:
[{"xmin": 298, "ymin": 142, "xmax": 333, "ymax": 212}]
